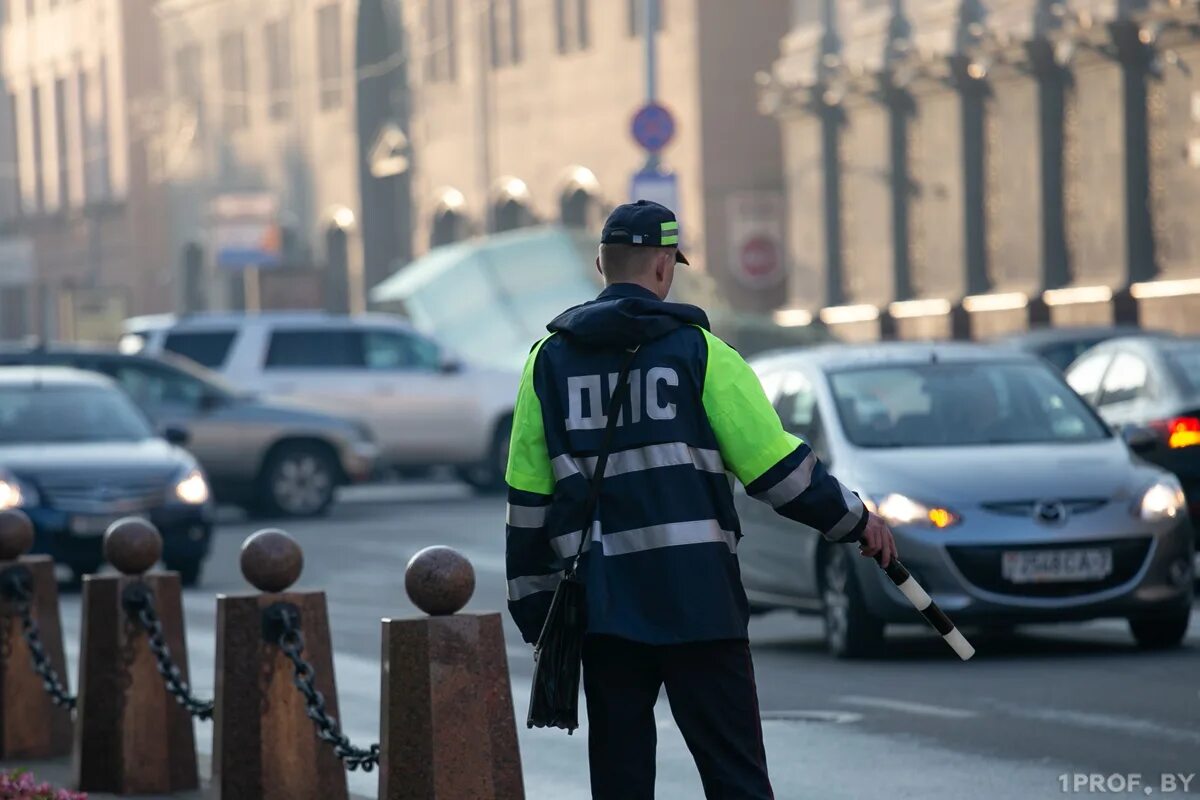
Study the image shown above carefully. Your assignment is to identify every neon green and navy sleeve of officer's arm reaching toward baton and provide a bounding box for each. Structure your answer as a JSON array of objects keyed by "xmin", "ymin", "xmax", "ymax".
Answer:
[{"xmin": 703, "ymin": 331, "xmax": 870, "ymax": 542}]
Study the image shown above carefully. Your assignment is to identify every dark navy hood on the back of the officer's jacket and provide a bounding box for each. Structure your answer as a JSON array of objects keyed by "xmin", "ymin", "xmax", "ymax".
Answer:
[{"xmin": 546, "ymin": 283, "xmax": 709, "ymax": 348}]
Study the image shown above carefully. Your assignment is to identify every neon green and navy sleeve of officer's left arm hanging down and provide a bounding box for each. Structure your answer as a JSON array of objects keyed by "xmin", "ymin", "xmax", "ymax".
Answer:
[{"xmin": 504, "ymin": 339, "xmax": 563, "ymax": 644}]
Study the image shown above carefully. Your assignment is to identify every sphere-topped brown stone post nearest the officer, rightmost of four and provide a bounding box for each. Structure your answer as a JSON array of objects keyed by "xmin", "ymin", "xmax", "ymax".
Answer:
[{"xmin": 379, "ymin": 547, "xmax": 524, "ymax": 800}]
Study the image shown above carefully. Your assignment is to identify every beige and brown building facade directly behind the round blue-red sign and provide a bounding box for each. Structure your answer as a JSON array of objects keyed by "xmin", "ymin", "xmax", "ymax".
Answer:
[{"xmin": 403, "ymin": 0, "xmax": 788, "ymax": 308}]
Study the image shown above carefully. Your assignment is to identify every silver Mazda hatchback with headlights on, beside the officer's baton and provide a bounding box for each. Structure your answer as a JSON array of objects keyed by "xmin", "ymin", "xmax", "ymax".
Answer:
[{"xmin": 736, "ymin": 343, "xmax": 1193, "ymax": 657}]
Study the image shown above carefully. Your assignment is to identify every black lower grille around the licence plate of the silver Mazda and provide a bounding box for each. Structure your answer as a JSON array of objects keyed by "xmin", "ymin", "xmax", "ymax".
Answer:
[{"xmin": 946, "ymin": 536, "xmax": 1152, "ymax": 597}]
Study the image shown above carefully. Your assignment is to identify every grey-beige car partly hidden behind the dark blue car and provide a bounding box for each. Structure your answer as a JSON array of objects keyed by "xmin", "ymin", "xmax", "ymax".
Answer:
[{"xmin": 0, "ymin": 344, "xmax": 379, "ymax": 517}]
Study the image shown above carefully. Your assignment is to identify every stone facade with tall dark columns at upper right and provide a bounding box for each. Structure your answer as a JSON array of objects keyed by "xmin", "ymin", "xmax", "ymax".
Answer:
[{"xmin": 760, "ymin": 0, "xmax": 1200, "ymax": 339}]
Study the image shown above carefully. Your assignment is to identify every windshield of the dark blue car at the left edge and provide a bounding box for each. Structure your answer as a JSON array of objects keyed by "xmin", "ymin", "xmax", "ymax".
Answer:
[{"xmin": 0, "ymin": 385, "xmax": 154, "ymax": 445}]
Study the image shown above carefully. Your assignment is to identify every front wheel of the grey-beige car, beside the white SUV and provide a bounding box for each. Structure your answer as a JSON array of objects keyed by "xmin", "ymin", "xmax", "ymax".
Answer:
[{"xmin": 260, "ymin": 443, "xmax": 337, "ymax": 517}]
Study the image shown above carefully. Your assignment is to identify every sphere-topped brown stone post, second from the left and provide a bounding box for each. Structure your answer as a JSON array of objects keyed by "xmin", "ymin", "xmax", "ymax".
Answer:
[{"xmin": 74, "ymin": 517, "xmax": 199, "ymax": 794}]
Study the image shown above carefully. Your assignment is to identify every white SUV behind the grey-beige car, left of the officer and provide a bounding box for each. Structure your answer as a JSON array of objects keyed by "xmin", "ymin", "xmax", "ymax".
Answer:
[{"xmin": 120, "ymin": 312, "xmax": 520, "ymax": 489}]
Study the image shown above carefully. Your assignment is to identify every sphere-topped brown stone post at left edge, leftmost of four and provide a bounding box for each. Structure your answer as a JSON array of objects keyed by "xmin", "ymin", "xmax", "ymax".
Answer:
[{"xmin": 0, "ymin": 510, "xmax": 71, "ymax": 760}]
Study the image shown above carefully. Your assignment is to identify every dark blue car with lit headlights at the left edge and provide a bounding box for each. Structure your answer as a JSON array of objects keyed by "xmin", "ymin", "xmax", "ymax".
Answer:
[{"xmin": 0, "ymin": 367, "xmax": 214, "ymax": 585}]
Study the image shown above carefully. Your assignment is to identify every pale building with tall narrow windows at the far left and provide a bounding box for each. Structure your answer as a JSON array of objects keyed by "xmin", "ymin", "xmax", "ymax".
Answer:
[{"xmin": 0, "ymin": 0, "xmax": 170, "ymax": 338}]
